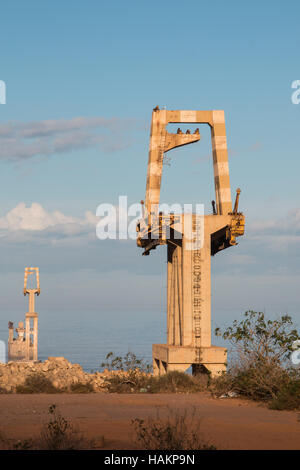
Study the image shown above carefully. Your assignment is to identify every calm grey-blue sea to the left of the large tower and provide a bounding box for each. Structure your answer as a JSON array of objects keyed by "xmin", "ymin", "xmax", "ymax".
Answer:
[{"xmin": 0, "ymin": 309, "xmax": 166, "ymax": 372}]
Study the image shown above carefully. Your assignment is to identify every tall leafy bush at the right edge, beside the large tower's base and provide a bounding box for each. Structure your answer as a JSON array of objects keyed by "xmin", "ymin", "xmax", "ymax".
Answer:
[{"xmin": 213, "ymin": 310, "xmax": 299, "ymax": 401}]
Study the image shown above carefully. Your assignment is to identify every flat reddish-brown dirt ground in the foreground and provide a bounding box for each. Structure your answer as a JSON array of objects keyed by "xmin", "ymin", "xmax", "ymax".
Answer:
[{"xmin": 0, "ymin": 393, "xmax": 300, "ymax": 450}]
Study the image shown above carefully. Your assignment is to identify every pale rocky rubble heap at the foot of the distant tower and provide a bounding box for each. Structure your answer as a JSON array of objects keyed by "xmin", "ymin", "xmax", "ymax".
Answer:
[{"xmin": 0, "ymin": 357, "xmax": 110, "ymax": 393}]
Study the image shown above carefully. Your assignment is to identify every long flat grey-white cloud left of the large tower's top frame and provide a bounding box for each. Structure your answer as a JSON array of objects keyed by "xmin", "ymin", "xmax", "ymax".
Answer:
[{"xmin": 0, "ymin": 117, "xmax": 135, "ymax": 160}]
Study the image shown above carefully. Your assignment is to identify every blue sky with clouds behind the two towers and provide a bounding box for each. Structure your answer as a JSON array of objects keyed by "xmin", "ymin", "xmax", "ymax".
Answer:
[{"xmin": 0, "ymin": 0, "xmax": 300, "ymax": 338}]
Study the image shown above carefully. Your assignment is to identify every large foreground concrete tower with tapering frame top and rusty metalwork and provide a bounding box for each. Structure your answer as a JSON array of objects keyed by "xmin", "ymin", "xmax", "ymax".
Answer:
[{"xmin": 137, "ymin": 107, "xmax": 245, "ymax": 376}]
